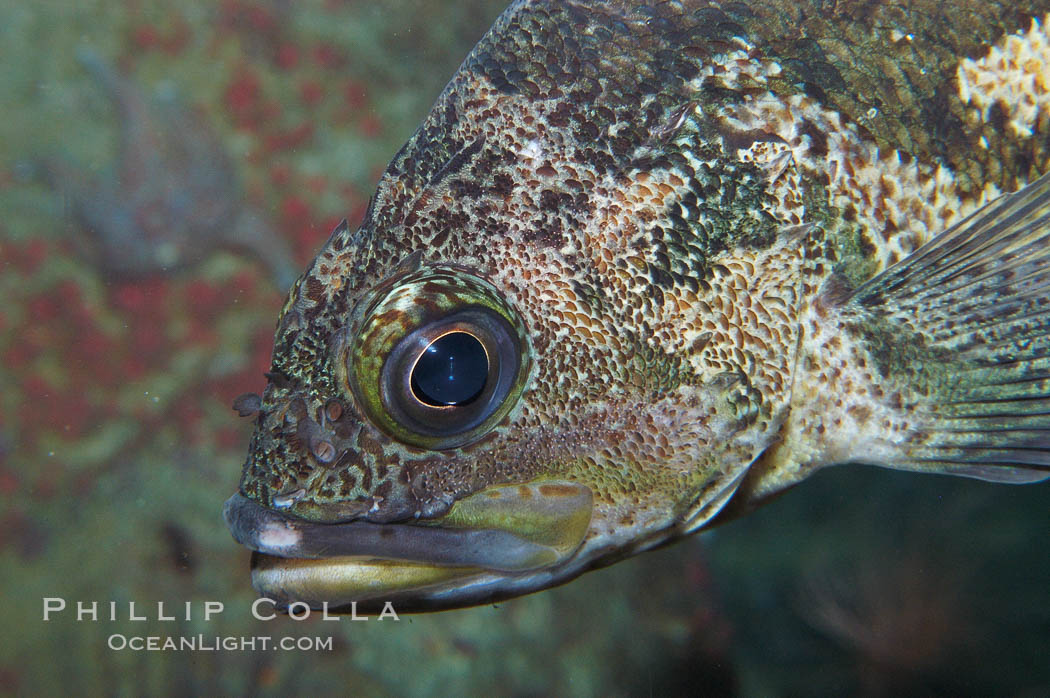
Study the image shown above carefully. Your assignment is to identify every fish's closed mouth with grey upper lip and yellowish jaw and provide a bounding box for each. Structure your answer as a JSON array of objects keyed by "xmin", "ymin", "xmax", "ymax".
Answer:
[{"xmin": 223, "ymin": 481, "xmax": 593, "ymax": 613}]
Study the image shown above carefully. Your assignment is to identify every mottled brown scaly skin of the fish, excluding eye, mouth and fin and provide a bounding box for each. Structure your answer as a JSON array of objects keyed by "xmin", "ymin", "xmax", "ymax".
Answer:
[{"xmin": 234, "ymin": 0, "xmax": 1050, "ymax": 596}]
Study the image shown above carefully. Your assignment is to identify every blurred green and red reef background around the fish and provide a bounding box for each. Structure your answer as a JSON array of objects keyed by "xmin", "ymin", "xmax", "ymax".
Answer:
[{"xmin": 0, "ymin": 0, "xmax": 1050, "ymax": 696}]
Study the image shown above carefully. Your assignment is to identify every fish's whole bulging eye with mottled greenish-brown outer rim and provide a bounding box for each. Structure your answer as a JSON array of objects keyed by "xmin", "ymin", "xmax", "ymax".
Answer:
[{"xmin": 343, "ymin": 267, "xmax": 529, "ymax": 449}]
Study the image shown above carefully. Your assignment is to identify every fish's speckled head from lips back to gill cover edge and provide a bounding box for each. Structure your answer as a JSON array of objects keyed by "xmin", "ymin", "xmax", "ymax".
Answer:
[{"xmin": 226, "ymin": 1, "xmax": 805, "ymax": 610}]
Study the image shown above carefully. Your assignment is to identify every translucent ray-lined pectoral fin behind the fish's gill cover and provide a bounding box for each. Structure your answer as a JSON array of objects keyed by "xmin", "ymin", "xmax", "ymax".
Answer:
[{"xmin": 840, "ymin": 175, "xmax": 1050, "ymax": 483}]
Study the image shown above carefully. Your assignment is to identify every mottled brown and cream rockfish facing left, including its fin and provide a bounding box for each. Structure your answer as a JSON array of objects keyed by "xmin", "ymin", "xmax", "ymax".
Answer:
[{"xmin": 225, "ymin": 0, "xmax": 1050, "ymax": 611}]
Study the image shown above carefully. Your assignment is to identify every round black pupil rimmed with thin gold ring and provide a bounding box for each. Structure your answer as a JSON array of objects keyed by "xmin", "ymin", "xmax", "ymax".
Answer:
[{"xmin": 412, "ymin": 332, "xmax": 488, "ymax": 407}]
